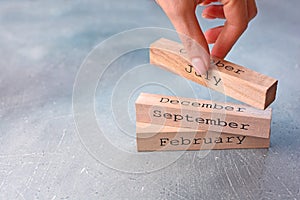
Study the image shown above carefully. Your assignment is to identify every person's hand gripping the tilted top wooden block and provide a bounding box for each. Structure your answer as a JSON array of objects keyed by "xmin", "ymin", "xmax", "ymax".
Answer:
[{"xmin": 156, "ymin": 0, "xmax": 257, "ymax": 74}]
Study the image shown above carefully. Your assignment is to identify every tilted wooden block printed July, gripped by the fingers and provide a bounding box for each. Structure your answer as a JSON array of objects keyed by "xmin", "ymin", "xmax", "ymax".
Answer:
[{"xmin": 150, "ymin": 38, "xmax": 277, "ymax": 109}]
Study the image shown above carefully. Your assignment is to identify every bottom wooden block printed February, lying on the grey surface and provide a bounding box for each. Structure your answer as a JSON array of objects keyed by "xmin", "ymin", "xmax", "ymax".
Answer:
[{"xmin": 136, "ymin": 122, "xmax": 270, "ymax": 151}]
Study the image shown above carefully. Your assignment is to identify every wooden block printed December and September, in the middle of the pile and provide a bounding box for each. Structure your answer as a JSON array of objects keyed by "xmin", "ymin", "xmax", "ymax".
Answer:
[{"xmin": 135, "ymin": 93, "xmax": 272, "ymax": 138}]
